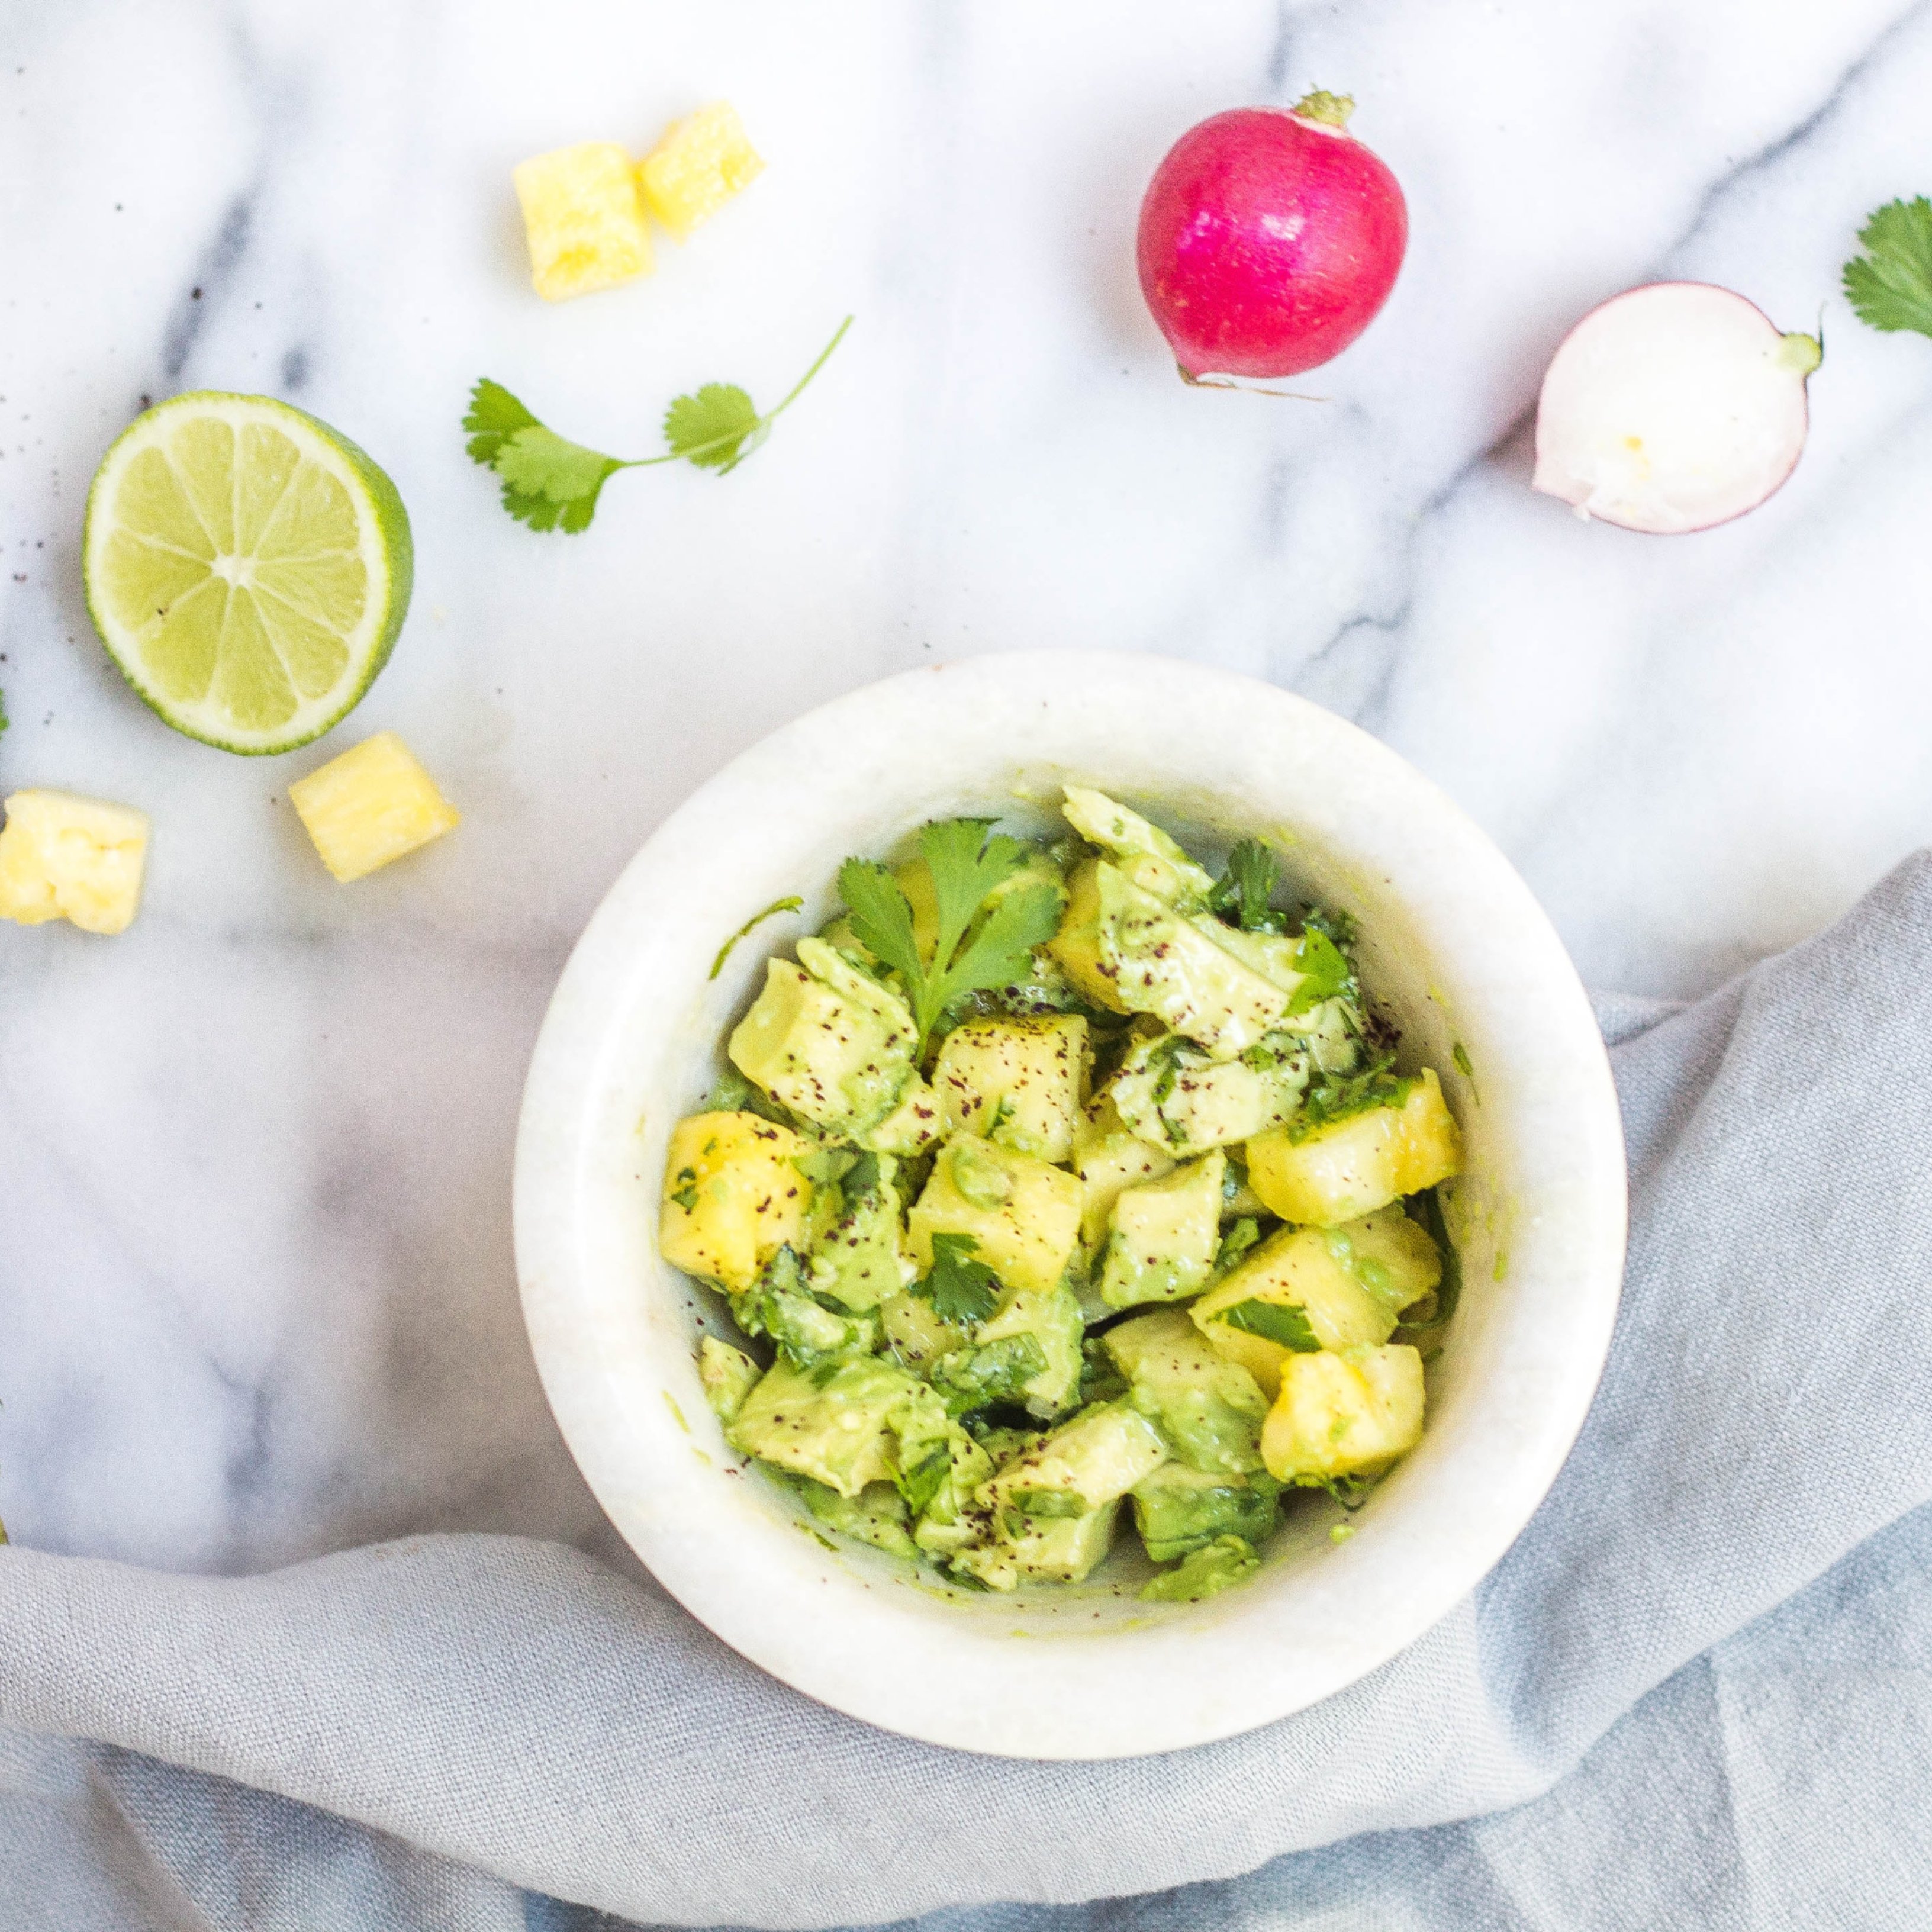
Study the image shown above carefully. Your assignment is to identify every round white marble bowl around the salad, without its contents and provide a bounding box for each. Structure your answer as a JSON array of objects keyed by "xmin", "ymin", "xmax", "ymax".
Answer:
[{"xmin": 516, "ymin": 653, "xmax": 1625, "ymax": 1758}]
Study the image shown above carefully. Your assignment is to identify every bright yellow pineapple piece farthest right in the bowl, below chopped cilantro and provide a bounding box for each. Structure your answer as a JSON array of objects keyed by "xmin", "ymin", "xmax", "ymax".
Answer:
[{"xmin": 1248, "ymin": 1068, "xmax": 1463, "ymax": 1227}]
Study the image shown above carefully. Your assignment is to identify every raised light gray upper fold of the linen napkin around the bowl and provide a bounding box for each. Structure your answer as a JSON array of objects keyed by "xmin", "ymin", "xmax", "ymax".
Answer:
[{"xmin": 0, "ymin": 854, "xmax": 1932, "ymax": 1928}]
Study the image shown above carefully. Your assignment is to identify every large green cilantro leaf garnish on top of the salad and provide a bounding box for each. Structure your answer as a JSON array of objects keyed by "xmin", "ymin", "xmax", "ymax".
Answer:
[{"xmin": 839, "ymin": 819, "xmax": 1061, "ymax": 1053}]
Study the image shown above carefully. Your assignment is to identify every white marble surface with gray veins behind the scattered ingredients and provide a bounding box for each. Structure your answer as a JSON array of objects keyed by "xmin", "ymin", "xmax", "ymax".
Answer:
[{"xmin": 0, "ymin": 0, "xmax": 1932, "ymax": 1569}]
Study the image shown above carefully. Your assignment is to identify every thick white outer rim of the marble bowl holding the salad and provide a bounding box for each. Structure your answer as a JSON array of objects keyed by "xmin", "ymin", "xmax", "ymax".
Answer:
[{"xmin": 514, "ymin": 651, "xmax": 1627, "ymax": 1758}]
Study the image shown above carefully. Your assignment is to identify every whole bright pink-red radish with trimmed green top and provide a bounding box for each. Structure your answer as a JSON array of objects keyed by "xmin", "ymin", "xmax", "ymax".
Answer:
[{"xmin": 1138, "ymin": 93, "xmax": 1408, "ymax": 382}]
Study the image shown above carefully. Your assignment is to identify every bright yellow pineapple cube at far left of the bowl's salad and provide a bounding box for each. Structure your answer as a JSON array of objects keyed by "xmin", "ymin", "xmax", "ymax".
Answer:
[{"xmin": 657, "ymin": 1113, "xmax": 813, "ymax": 1295}]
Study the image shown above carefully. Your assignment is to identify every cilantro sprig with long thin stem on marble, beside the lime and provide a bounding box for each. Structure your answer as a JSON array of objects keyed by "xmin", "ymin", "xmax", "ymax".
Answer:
[{"xmin": 463, "ymin": 315, "xmax": 852, "ymax": 535}]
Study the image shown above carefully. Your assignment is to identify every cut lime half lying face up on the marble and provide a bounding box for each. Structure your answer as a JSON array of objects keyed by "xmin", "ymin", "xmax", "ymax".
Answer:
[{"xmin": 81, "ymin": 390, "xmax": 413, "ymax": 754}]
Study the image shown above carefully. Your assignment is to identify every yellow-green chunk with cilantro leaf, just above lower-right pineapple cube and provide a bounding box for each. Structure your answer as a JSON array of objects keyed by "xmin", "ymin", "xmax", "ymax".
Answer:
[{"xmin": 1190, "ymin": 1208, "xmax": 1441, "ymax": 1393}]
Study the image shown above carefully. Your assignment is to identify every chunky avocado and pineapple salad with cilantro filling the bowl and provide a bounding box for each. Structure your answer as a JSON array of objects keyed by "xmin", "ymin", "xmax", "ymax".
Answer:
[{"xmin": 659, "ymin": 786, "xmax": 1461, "ymax": 1602}]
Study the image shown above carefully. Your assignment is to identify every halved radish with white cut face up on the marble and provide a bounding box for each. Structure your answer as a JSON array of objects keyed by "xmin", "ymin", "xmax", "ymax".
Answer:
[{"xmin": 1534, "ymin": 282, "xmax": 1822, "ymax": 535}]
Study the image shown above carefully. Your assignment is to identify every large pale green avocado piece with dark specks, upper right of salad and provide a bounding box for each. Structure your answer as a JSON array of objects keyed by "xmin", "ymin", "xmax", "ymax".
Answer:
[{"xmin": 1096, "ymin": 864, "xmax": 1289, "ymax": 1061}]
